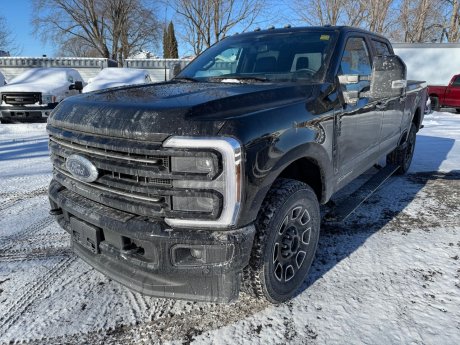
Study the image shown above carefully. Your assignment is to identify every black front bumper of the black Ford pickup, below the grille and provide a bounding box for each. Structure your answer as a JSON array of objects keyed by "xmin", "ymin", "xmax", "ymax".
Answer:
[{"xmin": 49, "ymin": 180, "xmax": 255, "ymax": 302}]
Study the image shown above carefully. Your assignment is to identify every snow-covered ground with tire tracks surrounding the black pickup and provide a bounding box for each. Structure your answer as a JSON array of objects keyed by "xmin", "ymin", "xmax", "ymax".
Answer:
[{"xmin": 0, "ymin": 113, "xmax": 460, "ymax": 344}]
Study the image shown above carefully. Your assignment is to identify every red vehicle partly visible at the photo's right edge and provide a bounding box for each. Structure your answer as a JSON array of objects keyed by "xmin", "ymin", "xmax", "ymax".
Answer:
[{"xmin": 428, "ymin": 74, "xmax": 460, "ymax": 113}]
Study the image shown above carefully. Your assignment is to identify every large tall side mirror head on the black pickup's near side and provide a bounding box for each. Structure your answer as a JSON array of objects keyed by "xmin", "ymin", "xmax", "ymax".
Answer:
[{"xmin": 370, "ymin": 55, "xmax": 407, "ymax": 99}]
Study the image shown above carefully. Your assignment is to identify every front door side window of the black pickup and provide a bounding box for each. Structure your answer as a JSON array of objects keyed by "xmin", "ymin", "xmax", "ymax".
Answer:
[{"xmin": 339, "ymin": 37, "xmax": 372, "ymax": 92}]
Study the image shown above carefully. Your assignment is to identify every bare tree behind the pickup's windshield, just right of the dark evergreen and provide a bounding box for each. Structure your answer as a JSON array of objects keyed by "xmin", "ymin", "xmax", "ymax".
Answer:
[{"xmin": 172, "ymin": 0, "xmax": 265, "ymax": 55}]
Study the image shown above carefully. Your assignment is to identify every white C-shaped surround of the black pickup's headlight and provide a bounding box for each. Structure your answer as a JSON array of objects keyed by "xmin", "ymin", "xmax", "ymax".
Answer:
[{"xmin": 163, "ymin": 137, "xmax": 242, "ymax": 228}]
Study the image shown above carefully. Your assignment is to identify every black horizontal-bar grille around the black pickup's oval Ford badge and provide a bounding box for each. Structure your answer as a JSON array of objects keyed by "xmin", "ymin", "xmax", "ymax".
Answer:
[{"xmin": 47, "ymin": 125, "xmax": 218, "ymax": 218}]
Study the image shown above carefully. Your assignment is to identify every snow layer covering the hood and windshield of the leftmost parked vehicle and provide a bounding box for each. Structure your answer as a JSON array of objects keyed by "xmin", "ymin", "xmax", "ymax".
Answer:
[{"xmin": 0, "ymin": 68, "xmax": 81, "ymax": 93}]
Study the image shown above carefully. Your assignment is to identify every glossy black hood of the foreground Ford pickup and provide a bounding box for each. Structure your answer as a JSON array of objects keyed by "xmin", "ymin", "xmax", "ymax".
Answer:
[{"xmin": 48, "ymin": 82, "xmax": 313, "ymax": 141}]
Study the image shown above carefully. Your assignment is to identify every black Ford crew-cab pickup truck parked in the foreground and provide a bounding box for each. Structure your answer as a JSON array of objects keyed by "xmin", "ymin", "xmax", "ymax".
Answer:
[{"xmin": 47, "ymin": 27, "xmax": 426, "ymax": 303}]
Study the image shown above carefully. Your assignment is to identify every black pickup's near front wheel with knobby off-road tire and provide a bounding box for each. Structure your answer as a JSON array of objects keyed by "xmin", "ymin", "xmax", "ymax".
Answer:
[{"xmin": 243, "ymin": 179, "xmax": 320, "ymax": 303}]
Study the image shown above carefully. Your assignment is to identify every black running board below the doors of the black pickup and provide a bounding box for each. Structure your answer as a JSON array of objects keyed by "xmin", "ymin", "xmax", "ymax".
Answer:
[{"xmin": 323, "ymin": 164, "xmax": 399, "ymax": 222}]
